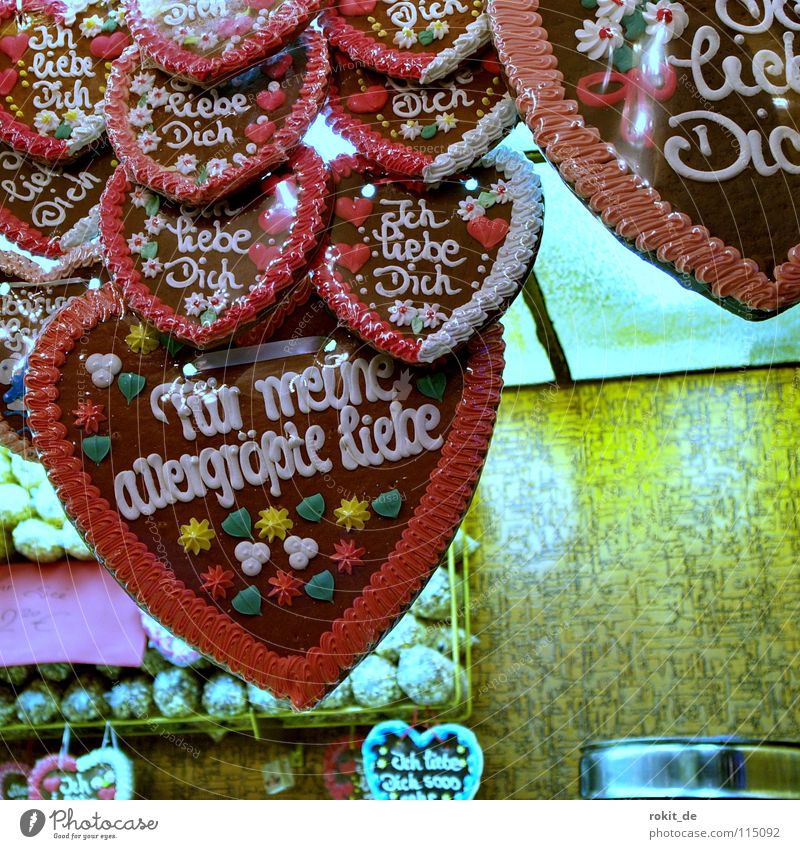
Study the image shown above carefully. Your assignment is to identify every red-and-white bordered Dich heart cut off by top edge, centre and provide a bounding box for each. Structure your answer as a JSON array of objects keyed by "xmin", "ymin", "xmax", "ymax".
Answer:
[{"xmin": 320, "ymin": 0, "xmax": 490, "ymax": 84}]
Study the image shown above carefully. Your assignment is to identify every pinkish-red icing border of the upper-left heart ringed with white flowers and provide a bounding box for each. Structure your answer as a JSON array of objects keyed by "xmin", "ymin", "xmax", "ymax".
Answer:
[{"xmin": 106, "ymin": 30, "xmax": 330, "ymax": 204}]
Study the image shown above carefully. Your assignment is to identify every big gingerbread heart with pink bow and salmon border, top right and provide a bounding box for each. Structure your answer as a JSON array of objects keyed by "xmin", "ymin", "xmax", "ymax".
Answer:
[{"xmin": 490, "ymin": 0, "xmax": 800, "ymax": 318}]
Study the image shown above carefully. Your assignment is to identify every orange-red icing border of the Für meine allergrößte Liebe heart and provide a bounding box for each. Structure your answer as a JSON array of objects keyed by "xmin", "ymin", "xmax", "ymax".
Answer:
[{"xmin": 26, "ymin": 286, "xmax": 504, "ymax": 708}]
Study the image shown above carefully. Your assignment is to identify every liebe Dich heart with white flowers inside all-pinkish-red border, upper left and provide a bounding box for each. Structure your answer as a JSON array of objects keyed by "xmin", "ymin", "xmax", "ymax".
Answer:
[{"xmin": 106, "ymin": 30, "xmax": 329, "ymax": 204}]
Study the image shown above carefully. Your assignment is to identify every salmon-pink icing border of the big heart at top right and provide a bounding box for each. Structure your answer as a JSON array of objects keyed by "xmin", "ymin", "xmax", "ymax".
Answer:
[{"xmin": 488, "ymin": 0, "xmax": 800, "ymax": 311}]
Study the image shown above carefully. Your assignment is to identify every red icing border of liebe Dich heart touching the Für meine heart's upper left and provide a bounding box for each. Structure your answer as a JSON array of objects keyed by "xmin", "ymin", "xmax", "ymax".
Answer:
[{"xmin": 100, "ymin": 145, "xmax": 332, "ymax": 348}]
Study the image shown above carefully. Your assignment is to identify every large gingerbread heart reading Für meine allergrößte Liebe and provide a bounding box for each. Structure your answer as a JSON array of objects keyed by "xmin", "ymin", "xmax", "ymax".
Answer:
[{"xmin": 27, "ymin": 287, "xmax": 503, "ymax": 707}]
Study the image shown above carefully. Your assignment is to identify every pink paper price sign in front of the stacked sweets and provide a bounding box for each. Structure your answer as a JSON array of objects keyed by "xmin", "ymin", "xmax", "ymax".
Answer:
[{"xmin": 0, "ymin": 563, "xmax": 145, "ymax": 666}]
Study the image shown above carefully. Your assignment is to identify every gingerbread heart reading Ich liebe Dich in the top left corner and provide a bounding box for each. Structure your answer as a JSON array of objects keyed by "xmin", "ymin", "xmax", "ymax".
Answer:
[{"xmin": 0, "ymin": 0, "xmax": 130, "ymax": 163}]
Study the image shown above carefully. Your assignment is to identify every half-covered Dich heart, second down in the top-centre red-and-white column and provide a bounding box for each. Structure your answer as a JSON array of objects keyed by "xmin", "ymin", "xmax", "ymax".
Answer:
[{"xmin": 326, "ymin": 48, "xmax": 517, "ymax": 183}]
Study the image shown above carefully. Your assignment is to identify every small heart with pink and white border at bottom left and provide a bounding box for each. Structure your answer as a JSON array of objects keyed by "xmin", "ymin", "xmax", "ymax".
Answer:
[{"xmin": 28, "ymin": 746, "xmax": 133, "ymax": 802}]
